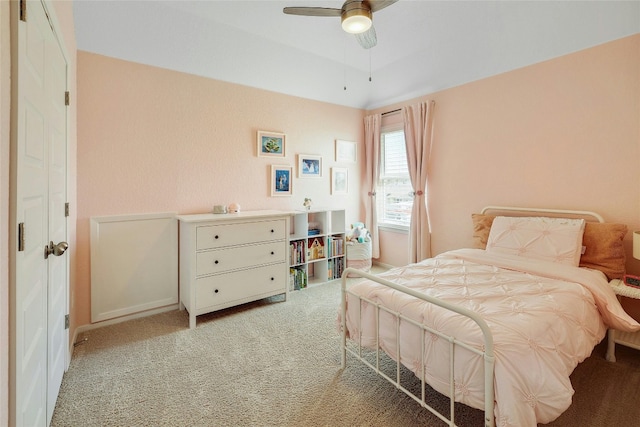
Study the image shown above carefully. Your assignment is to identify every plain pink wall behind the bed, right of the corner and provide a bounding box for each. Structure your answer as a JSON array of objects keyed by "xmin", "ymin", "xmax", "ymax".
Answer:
[{"xmin": 375, "ymin": 35, "xmax": 640, "ymax": 274}]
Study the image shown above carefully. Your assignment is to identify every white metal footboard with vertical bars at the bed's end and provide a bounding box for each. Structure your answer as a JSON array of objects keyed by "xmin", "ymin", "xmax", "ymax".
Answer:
[{"xmin": 340, "ymin": 268, "xmax": 495, "ymax": 427}]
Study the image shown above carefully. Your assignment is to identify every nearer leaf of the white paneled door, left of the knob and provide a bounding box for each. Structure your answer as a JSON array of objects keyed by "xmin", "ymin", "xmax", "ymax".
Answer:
[{"xmin": 12, "ymin": 0, "xmax": 50, "ymax": 426}]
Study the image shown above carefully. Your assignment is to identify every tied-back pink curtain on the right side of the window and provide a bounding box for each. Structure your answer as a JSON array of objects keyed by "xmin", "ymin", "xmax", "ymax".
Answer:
[{"xmin": 402, "ymin": 101, "xmax": 435, "ymax": 263}]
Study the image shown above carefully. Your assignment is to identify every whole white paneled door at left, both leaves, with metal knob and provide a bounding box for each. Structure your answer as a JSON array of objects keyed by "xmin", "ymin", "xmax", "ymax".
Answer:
[{"xmin": 10, "ymin": 1, "xmax": 68, "ymax": 426}]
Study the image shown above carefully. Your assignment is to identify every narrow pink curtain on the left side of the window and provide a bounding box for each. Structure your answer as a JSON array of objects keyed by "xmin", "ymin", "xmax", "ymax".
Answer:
[{"xmin": 364, "ymin": 114, "xmax": 382, "ymax": 258}]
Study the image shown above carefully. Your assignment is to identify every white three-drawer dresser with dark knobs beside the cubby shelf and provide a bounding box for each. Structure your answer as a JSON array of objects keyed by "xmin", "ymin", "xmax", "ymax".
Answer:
[{"xmin": 177, "ymin": 210, "xmax": 290, "ymax": 328}]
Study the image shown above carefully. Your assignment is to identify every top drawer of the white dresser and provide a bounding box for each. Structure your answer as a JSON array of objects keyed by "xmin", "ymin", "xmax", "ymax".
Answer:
[{"xmin": 196, "ymin": 220, "xmax": 286, "ymax": 250}]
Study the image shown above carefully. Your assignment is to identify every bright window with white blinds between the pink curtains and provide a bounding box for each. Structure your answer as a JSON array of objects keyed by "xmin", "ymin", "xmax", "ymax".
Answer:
[{"xmin": 376, "ymin": 129, "xmax": 413, "ymax": 228}]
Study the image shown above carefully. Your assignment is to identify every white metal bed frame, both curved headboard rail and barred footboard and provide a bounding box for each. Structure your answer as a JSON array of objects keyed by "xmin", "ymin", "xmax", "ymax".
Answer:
[{"xmin": 341, "ymin": 206, "xmax": 604, "ymax": 427}]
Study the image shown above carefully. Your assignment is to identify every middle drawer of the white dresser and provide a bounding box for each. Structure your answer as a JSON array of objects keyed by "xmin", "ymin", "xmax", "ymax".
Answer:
[{"xmin": 196, "ymin": 242, "xmax": 286, "ymax": 276}]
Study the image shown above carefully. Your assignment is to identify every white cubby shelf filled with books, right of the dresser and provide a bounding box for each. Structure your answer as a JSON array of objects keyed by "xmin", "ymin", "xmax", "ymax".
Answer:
[{"xmin": 289, "ymin": 209, "xmax": 345, "ymax": 290}]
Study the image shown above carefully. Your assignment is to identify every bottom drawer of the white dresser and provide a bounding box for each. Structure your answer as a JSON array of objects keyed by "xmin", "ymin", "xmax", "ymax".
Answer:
[{"xmin": 196, "ymin": 264, "xmax": 287, "ymax": 310}]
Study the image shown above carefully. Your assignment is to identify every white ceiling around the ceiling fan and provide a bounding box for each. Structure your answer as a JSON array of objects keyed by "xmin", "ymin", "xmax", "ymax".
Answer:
[{"xmin": 74, "ymin": 0, "xmax": 640, "ymax": 109}]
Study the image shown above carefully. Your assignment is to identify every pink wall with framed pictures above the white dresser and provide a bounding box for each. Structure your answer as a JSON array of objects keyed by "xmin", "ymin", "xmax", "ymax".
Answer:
[{"xmin": 75, "ymin": 51, "xmax": 364, "ymax": 325}]
